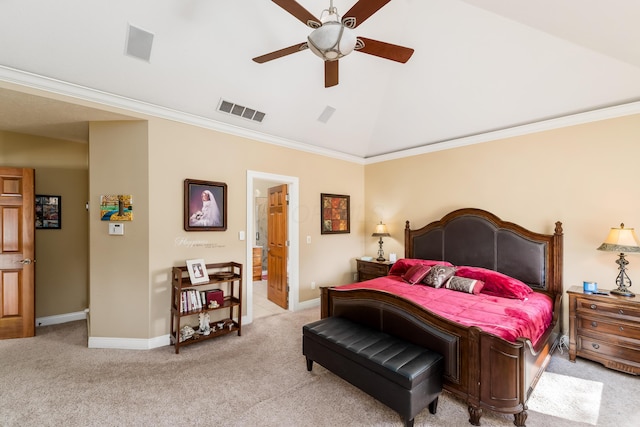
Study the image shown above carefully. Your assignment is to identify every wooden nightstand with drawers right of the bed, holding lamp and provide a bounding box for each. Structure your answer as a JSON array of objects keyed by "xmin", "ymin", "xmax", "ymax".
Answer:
[{"xmin": 567, "ymin": 286, "xmax": 640, "ymax": 375}]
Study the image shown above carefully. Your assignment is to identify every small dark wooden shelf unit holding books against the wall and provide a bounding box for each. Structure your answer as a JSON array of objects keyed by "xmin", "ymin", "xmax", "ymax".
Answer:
[{"xmin": 170, "ymin": 262, "xmax": 242, "ymax": 354}]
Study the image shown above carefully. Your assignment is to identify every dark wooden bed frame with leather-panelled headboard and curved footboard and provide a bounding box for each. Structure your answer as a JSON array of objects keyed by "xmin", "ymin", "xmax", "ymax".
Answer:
[{"xmin": 321, "ymin": 208, "xmax": 563, "ymax": 426}]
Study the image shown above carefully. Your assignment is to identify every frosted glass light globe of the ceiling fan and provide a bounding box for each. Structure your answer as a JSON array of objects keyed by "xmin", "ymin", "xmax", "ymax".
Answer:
[{"xmin": 307, "ymin": 21, "xmax": 356, "ymax": 61}]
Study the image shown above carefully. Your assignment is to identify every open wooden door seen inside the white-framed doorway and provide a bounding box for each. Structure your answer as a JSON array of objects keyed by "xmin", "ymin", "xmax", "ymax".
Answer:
[{"xmin": 267, "ymin": 184, "xmax": 289, "ymax": 309}]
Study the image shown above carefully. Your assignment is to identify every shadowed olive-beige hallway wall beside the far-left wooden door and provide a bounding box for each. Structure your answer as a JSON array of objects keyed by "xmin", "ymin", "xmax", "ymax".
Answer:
[{"xmin": 0, "ymin": 132, "xmax": 88, "ymax": 318}]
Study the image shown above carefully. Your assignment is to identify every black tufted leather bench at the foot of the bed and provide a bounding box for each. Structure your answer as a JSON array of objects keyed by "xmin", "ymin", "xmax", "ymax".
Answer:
[{"xmin": 302, "ymin": 317, "xmax": 444, "ymax": 427}]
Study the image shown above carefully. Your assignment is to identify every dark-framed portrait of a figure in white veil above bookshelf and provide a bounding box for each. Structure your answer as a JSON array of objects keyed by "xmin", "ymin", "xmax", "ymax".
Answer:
[{"xmin": 184, "ymin": 179, "xmax": 227, "ymax": 231}]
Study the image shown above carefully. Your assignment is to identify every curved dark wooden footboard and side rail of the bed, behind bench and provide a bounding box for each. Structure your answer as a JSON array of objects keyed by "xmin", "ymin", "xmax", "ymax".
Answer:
[{"xmin": 321, "ymin": 288, "xmax": 560, "ymax": 426}]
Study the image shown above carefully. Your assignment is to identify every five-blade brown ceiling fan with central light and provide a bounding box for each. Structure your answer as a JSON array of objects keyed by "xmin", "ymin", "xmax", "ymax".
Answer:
[{"xmin": 253, "ymin": 0, "xmax": 413, "ymax": 87}]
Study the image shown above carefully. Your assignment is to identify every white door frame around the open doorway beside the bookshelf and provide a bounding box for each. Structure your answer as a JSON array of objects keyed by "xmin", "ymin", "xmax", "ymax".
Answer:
[{"xmin": 242, "ymin": 170, "xmax": 300, "ymax": 324}]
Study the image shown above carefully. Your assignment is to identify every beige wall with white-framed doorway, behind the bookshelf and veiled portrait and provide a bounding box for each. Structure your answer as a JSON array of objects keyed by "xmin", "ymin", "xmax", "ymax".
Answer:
[{"xmin": 149, "ymin": 120, "xmax": 364, "ymax": 336}]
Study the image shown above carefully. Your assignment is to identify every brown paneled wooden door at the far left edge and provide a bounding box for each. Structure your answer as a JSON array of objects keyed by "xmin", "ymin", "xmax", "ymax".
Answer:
[{"xmin": 0, "ymin": 167, "xmax": 36, "ymax": 338}]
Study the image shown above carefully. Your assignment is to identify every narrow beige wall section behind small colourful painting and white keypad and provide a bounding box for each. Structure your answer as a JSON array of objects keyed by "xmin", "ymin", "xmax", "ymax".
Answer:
[{"xmin": 89, "ymin": 121, "xmax": 149, "ymax": 338}]
